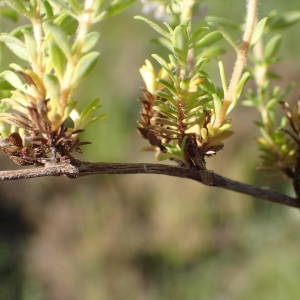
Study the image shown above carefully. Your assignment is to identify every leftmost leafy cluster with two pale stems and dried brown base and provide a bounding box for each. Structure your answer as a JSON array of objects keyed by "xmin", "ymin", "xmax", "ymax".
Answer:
[{"xmin": 0, "ymin": 0, "xmax": 107, "ymax": 165}]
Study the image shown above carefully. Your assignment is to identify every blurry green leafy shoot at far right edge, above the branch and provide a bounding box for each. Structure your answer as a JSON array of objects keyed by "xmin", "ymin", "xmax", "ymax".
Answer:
[{"xmin": 243, "ymin": 11, "xmax": 300, "ymax": 178}]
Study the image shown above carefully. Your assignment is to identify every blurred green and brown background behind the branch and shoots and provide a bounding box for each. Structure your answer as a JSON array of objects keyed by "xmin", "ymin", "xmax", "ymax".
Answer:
[{"xmin": 0, "ymin": 0, "xmax": 300, "ymax": 300}]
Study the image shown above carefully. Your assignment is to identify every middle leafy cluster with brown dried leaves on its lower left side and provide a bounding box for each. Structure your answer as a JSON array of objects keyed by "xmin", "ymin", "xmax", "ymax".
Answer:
[{"xmin": 137, "ymin": 17, "xmax": 233, "ymax": 169}]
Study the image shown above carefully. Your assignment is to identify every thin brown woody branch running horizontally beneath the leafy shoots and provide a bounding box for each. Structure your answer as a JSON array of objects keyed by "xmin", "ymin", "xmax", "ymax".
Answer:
[{"xmin": 0, "ymin": 161, "xmax": 300, "ymax": 208}]
